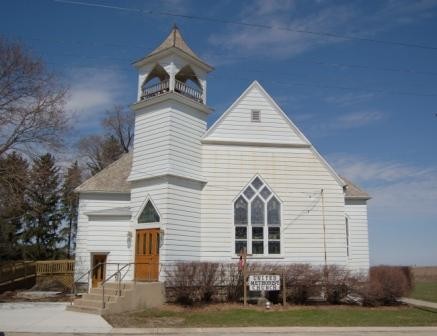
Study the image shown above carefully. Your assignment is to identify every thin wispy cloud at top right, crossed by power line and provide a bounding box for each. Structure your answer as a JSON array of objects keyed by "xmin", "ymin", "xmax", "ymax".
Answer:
[{"xmin": 209, "ymin": 0, "xmax": 437, "ymax": 60}]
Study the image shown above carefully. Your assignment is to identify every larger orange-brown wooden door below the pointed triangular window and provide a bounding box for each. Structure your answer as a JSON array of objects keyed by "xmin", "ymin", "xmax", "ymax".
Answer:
[{"xmin": 135, "ymin": 229, "xmax": 160, "ymax": 281}]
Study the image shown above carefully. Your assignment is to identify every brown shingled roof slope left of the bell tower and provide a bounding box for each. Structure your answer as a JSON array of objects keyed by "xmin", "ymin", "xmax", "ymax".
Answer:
[{"xmin": 75, "ymin": 152, "xmax": 132, "ymax": 193}]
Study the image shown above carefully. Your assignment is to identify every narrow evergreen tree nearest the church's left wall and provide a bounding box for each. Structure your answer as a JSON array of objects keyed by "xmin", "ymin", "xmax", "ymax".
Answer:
[{"xmin": 62, "ymin": 161, "xmax": 82, "ymax": 258}]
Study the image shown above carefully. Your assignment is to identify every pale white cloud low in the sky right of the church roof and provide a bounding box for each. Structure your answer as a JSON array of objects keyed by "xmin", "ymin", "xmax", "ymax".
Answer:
[{"xmin": 330, "ymin": 154, "xmax": 437, "ymax": 215}]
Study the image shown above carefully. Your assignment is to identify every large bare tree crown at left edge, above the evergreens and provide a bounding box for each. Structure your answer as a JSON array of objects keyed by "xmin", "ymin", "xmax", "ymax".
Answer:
[{"xmin": 0, "ymin": 36, "xmax": 67, "ymax": 157}]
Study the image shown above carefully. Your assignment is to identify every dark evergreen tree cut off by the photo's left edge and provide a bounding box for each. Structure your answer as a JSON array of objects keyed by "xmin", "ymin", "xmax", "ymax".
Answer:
[{"xmin": 0, "ymin": 152, "xmax": 29, "ymax": 261}]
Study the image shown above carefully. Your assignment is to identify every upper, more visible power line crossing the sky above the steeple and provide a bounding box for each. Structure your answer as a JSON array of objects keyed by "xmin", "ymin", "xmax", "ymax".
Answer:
[{"xmin": 53, "ymin": 0, "xmax": 437, "ymax": 50}]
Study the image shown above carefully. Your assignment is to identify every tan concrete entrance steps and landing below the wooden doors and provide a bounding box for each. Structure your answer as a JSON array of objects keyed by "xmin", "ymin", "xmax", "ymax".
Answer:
[{"xmin": 67, "ymin": 282, "xmax": 164, "ymax": 315}]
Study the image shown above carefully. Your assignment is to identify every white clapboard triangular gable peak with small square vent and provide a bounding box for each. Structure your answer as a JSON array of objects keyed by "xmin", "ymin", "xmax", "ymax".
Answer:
[{"xmin": 204, "ymin": 82, "xmax": 307, "ymax": 144}]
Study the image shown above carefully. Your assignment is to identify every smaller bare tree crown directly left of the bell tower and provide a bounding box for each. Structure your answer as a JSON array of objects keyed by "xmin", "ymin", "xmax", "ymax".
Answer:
[{"xmin": 102, "ymin": 105, "xmax": 135, "ymax": 153}]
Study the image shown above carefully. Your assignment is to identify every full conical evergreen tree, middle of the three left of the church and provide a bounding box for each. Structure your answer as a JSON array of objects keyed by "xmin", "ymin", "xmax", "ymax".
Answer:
[{"xmin": 22, "ymin": 153, "xmax": 63, "ymax": 260}]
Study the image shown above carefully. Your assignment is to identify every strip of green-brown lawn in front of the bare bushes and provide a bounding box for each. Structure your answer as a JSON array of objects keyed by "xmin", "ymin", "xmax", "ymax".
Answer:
[{"xmin": 105, "ymin": 305, "xmax": 437, "ymax": 328}]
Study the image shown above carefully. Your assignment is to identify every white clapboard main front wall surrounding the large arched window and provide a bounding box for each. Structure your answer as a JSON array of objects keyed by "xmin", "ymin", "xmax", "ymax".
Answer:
[{"xmin": 201, "ymin": 144, "xmax": 347, "ymax": 265}]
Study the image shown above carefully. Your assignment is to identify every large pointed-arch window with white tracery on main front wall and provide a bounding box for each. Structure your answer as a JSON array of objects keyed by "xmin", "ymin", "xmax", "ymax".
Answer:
[{"xmin": 234, "ymin": 176, "xmax": 281, "ymax": 255}]
